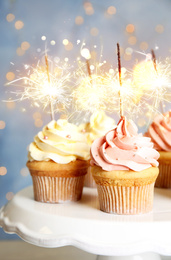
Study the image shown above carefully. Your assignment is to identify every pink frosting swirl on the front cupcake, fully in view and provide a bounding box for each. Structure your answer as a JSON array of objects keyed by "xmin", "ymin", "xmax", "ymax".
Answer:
[{"xmin": 91, "ymin": 117, "xmax": 159, "ymax": 171}]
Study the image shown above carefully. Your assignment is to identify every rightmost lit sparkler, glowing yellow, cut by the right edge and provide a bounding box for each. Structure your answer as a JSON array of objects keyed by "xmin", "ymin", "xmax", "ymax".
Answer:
[{"xmin": 133, "ymin": 55, "xmax": 171, "ymax": 114}]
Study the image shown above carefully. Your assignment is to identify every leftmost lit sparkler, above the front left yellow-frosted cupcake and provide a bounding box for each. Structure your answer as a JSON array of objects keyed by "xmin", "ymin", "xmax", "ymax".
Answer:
[{"xmin": 7, "ymin": 55, "xmax": 71, "ymax": 120}]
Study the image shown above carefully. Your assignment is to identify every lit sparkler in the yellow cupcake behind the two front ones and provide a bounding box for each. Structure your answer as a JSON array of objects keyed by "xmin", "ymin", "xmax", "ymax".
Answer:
[{"xmin": 72, "ymin": 48, "xmax": 115, "ymax": 113}]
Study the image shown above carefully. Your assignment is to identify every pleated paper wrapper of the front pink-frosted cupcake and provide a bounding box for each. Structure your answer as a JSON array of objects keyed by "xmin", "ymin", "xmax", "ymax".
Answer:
[{"xmin": 97, "ymin": 183, "xmax": 154, "ymax": 215}]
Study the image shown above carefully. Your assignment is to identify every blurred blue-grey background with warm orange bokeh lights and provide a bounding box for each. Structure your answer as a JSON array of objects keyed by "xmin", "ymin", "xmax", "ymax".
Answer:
[{"xmin": 0, "ymin": 0, "xmax": 171, "ymax": 240}]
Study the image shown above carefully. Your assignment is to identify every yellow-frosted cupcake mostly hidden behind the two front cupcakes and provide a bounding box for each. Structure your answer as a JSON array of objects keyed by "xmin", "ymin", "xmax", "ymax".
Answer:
[{"xmin": 79, "ymin": 111, "xmax": 115, "ymax": 188}]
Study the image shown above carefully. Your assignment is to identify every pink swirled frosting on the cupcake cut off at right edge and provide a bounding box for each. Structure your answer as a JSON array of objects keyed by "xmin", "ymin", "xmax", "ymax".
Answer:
[{"xmin": 145, "ymin": 111, "xmax": 171, "ymax": 152}]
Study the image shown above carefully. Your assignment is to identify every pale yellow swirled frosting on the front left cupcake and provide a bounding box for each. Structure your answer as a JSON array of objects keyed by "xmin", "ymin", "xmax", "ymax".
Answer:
[{"xmin": 28, "ymin": 119, "xmax": 90, "ymax": 164}]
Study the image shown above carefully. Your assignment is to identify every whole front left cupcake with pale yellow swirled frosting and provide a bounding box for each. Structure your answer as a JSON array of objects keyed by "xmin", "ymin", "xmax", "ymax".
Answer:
[{"xmin": 27, "ymin": 119, "xmax": 90, "ymax": 203}]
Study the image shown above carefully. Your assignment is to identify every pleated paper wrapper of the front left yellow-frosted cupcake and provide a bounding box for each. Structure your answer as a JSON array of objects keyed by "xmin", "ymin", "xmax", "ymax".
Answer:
[{"xmin": 32, "ymin": 175, "xmax": 85, "ymax": 203}]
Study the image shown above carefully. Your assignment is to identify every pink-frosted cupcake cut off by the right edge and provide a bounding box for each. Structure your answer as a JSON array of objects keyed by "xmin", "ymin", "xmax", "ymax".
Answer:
[{"xmin": 145, "ymin": 111, "xmax": 171, "ymax": 188}]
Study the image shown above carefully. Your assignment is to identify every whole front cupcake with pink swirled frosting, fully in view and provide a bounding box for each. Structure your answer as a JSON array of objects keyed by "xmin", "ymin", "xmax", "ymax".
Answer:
[{"xmin": 91, "ymin": 117, "xmax": 159, "ymax": 215}]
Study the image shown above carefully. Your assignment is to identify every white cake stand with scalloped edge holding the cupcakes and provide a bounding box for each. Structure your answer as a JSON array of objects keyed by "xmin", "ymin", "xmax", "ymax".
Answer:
[{"xmin": 0, "ymin": 187, "xmax": 171, "ymax": 260}]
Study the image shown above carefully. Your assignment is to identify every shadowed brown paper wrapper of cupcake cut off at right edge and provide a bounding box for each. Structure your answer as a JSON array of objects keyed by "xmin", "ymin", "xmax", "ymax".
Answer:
[{"xmin": 155, "ymin": 163, "xmax": 171, "ymax": 189}]
